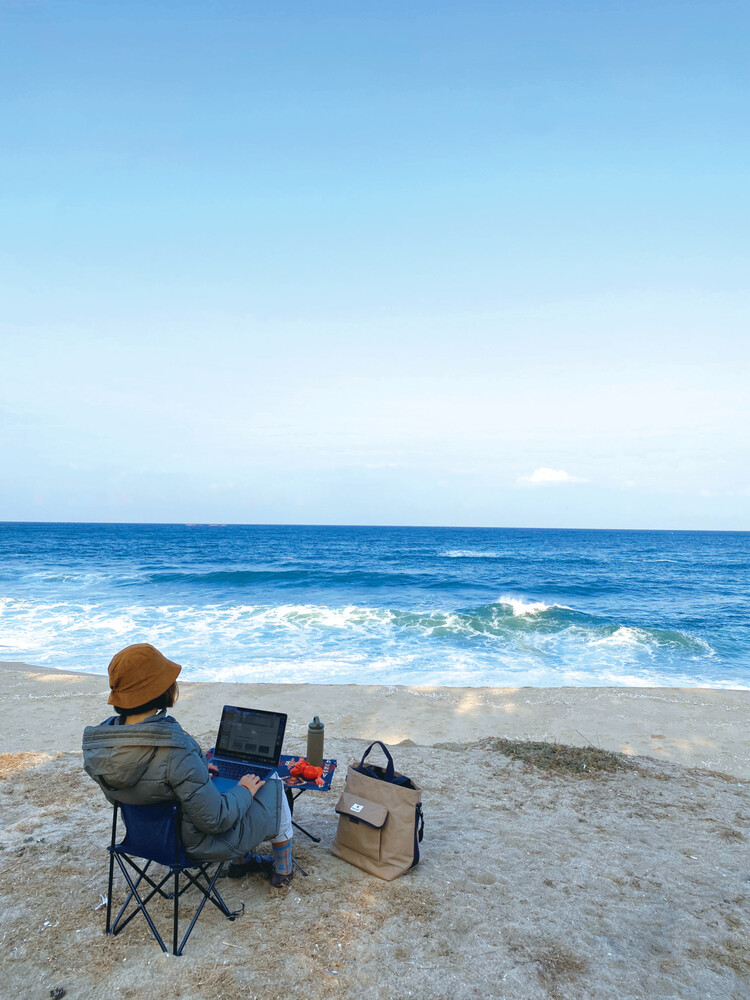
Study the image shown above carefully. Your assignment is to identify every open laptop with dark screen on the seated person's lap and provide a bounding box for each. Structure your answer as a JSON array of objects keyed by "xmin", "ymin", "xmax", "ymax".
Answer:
[{"xmin": 211, "ymin": 705, "xmax": 287, "ymax": 792}]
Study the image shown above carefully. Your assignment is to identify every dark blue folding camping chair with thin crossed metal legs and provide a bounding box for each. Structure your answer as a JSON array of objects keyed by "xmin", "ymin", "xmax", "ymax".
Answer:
[{"xmin": 107, "ymin": 802, "xmax": 239, "ymax": 955}]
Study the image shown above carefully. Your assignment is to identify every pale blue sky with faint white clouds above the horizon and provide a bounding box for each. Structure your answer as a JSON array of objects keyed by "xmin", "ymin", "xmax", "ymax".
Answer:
[{"xmin": 0, "ymin": 0, "xmax": 750, "ymax": 530}]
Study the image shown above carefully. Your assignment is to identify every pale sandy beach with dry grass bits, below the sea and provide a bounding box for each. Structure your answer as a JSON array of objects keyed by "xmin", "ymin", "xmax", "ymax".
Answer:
[{"xmin": 0, "ymin": 663, "xmax": 750, "ymax": 1000}]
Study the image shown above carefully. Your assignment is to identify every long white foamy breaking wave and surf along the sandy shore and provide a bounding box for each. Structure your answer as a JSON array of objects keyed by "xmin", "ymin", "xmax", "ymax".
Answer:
[{"xmin": 0, "ymin": 596, "xmax": 728, "ymax": 686}]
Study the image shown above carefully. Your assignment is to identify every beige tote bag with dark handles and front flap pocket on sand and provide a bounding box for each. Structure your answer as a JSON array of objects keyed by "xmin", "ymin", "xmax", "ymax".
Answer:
[{"xmin": 331, "ymin": 740, "xmax": 424, "ymax": 881}]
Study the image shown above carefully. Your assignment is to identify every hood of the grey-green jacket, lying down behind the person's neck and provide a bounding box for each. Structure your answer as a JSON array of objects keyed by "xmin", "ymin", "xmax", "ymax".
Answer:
[{"xmin": 82, "ymin": 714, "xmax": 194, "ymax": 789}]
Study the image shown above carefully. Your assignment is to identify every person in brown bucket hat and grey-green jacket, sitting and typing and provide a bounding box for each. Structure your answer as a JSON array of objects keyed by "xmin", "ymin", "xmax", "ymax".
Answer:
[{"xmin": 83, "ymin": 643, "xmax": 293, "ymax": 888}]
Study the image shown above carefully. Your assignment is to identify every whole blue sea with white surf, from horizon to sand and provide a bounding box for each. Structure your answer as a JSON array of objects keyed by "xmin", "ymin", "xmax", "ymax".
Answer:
[{"xmin": 0, "ymin": 523, "xmax": 750, "ymax": 689}]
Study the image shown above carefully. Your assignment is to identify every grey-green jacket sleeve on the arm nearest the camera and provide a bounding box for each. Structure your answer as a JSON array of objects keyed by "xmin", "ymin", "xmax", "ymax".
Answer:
[{"xmin": 167, "ymin": 746, "xmax": 253, "ymax": 834}]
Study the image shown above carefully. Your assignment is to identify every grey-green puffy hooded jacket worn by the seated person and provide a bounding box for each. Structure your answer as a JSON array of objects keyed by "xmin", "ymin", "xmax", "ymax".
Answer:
[{"xmin": 83, "ymin": 711, "xmax": 283, "ymax": 861}]
